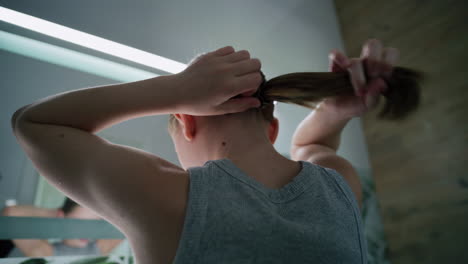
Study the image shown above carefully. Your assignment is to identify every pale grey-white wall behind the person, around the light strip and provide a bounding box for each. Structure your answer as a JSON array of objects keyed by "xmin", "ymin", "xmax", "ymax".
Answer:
[{"xmin": 0, "ymin": 0, "xmax": 369, "ymax": 208}]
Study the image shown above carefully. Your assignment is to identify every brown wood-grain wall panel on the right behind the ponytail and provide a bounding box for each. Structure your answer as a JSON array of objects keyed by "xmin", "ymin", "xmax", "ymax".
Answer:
[{"xmin": 335, "ymin": 0, "xmax": 468, "ymax": 264}]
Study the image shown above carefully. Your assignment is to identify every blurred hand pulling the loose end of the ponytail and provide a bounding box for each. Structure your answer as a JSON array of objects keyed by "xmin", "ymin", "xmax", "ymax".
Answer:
[{"xmin": 322, "ymin": 39, "xmax": 399, "ymax": 118}]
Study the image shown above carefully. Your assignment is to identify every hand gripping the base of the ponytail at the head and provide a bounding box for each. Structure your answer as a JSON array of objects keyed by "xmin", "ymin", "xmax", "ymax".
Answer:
[{"xmin": 174, "ymin": 46, "xmax": 262, "ymax": 116}]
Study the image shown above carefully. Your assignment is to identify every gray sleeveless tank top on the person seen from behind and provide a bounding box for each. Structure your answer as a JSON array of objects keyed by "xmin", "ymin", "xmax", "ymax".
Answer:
[{"xmin": 173, "ymin": 159, "xmax": 367, "ymax": 264}]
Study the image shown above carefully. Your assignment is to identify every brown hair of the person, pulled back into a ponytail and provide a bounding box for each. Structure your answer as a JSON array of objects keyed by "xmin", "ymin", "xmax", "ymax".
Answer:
[{"xmin": 168, "ymin": 60, "xmax": 424, "ymax": 134}]
